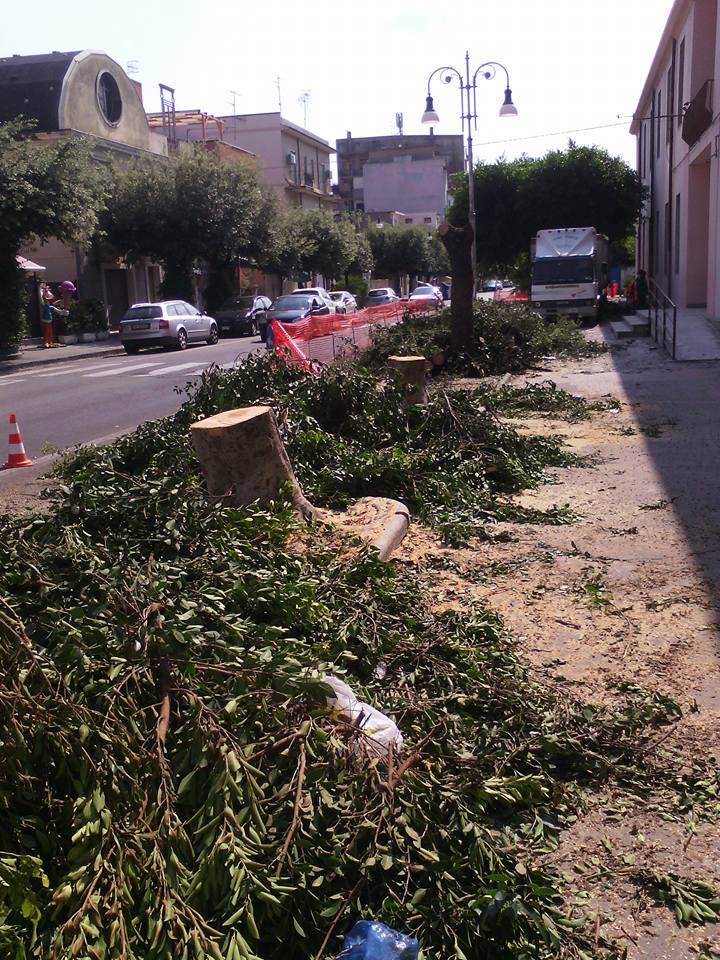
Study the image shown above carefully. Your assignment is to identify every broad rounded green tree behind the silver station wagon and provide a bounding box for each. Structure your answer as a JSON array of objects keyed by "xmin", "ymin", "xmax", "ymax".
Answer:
[{"xmin": 103, "ymin": 147, "xmax": 274, "ymax": 300}]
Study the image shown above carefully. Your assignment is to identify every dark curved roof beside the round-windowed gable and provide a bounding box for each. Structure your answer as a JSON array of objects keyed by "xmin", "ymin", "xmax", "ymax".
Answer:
[{"xmin": 0, "ymin": 50, "xmax": 81, "ymax": 131}]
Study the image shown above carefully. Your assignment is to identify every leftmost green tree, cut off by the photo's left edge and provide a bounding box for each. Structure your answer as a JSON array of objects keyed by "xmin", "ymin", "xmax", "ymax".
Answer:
[{"xmin": 0, "ymin": 118, "xmax": 105, "ymax": 352}]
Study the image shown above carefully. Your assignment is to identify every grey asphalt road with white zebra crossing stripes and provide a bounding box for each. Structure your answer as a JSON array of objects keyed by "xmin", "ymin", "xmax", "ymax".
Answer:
[{"xmin": 0, "ymin": 337, "xmax": 265, "ymax": 464}]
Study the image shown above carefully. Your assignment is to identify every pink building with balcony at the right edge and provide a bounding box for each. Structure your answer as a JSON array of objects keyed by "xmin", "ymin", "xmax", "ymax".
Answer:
[{"xmin": 631, "ymin": 0, "xmax": 720, "ymax": 319}]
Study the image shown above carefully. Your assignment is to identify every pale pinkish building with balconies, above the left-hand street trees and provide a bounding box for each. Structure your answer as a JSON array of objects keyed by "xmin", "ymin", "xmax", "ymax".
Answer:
[{"xmin": 169, "ymin": 113, "xmax": 339, "ymax": 212}]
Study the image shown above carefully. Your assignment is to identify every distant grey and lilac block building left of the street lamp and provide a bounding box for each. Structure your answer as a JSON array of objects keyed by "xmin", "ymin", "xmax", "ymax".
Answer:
[{"xmin": 336, "ymin": 131, "xmax": 465, "ymax": 222}]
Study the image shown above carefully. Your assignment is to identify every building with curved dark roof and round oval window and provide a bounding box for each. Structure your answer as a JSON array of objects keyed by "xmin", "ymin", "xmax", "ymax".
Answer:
[{"xmin": 0, "ymin": 50, "xmax": 168, "ymax": 322}]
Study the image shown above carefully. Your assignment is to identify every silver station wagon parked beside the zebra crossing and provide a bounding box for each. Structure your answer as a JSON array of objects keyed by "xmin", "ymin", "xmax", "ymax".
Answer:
[{"xmin": 120, "ymin": 300, "xmax": 218, "ymax": 353}]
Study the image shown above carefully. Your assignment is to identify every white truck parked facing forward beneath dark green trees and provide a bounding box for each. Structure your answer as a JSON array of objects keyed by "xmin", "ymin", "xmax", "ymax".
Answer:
[{"xmin": 530, "ymin": 227, "xmax": 608, "ymax": 320}]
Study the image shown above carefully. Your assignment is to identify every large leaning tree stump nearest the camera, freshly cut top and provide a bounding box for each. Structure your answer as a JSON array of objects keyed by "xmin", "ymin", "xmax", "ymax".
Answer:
[{"xmin": 190, "ymin": 407, "xmax": 315, "ymax": 517}]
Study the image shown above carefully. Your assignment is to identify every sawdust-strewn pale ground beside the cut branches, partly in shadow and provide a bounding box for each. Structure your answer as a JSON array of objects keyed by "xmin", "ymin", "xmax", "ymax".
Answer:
[{"xmin": 398, "ymin": 331, "xmax": 720, "ymax": 960}]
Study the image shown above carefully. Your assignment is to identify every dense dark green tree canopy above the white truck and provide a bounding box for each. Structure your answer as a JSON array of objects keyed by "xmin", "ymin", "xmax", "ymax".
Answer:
[{"xmin": 449, "ymin": 141, "xmax": 642, "ymax": 280}]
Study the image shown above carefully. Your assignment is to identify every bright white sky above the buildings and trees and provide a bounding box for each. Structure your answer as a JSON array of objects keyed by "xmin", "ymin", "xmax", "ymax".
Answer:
[{"xmin": 0, "ymin": 0, "xmax": 672, "ymax": 166}]
